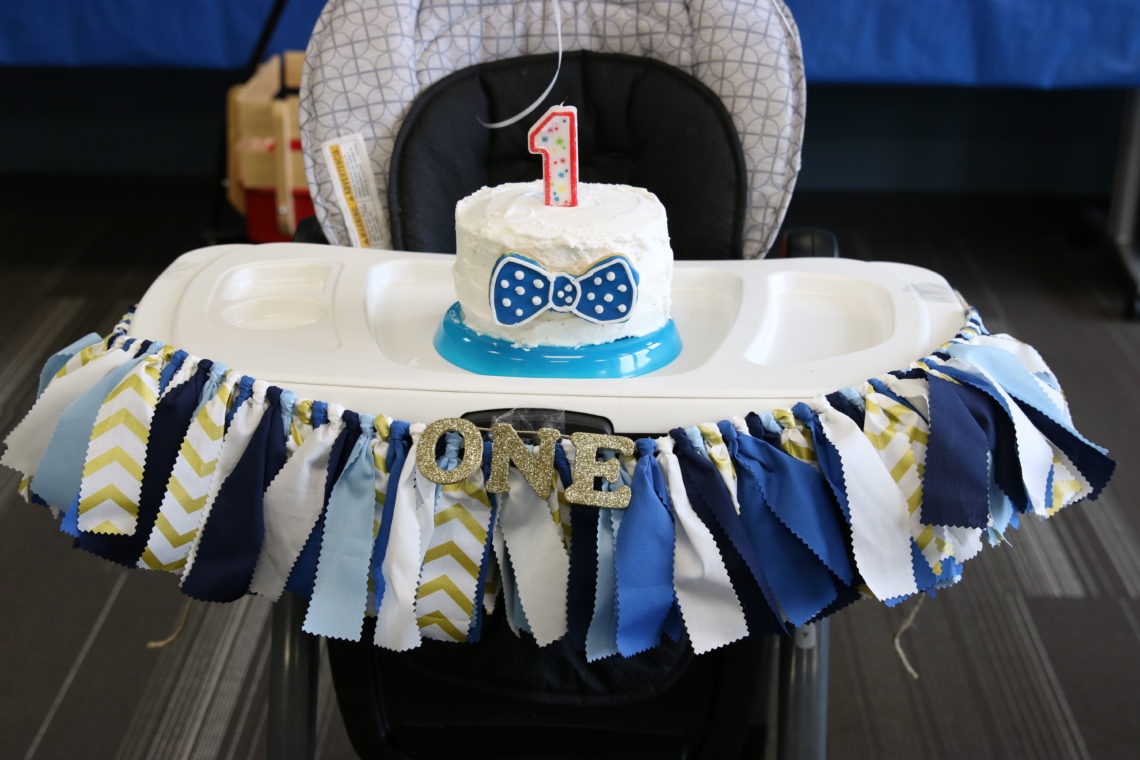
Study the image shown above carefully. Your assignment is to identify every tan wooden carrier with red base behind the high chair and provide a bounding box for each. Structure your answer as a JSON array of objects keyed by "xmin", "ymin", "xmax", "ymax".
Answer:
[{"xmin": 226, "ymin": 51, "xmax": 312, "ymax": 243}]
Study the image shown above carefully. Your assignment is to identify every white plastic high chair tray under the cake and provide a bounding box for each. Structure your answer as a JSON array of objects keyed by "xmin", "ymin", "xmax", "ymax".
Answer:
[{"xmin": 130, "ymin": 243, "xmax": 964, "ymax": 432}]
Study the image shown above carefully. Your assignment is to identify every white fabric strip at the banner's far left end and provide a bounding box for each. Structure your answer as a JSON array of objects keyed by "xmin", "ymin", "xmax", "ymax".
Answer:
[{"xmin": 0, "ymin": 339, "xmax": 135, "ymax": 475}]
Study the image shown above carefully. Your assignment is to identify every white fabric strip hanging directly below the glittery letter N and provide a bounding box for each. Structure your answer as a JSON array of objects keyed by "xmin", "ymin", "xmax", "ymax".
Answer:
[{"xmin": 499, "ymin": 468, "xmax": 570, "ymax": 646}]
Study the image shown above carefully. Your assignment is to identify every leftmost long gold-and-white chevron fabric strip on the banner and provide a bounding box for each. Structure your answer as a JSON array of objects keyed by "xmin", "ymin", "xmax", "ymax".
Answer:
[{"xmin": 79, "ymin": 346, "xmax": 168, "ymax": 536}]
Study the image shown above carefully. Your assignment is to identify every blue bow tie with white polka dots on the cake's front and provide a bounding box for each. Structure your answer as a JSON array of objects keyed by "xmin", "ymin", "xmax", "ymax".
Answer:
[{"xmin": 490, "ymin": 253, "xmax": 637, "ymax": 325}]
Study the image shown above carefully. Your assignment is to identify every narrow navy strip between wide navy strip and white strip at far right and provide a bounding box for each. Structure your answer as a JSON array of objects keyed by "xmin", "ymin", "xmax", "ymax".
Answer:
[{"xmin": 937, "ymin": 366, "xmax": 1029, "ymax": 512}]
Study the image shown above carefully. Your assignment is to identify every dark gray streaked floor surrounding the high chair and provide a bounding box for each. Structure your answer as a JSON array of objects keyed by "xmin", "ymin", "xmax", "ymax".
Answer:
[{"xmin": 0, "ymin": 180, "xmax": 1140, "ymax": 760}]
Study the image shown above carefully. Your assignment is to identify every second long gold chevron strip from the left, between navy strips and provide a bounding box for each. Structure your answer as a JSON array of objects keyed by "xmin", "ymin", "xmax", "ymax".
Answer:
[{"xmin": 139, "ymin": 370, "xmax": 239, "ymax": 572}]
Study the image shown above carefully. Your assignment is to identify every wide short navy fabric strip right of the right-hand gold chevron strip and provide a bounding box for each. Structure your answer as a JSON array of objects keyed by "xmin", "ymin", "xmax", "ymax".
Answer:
[{"xmin": 922, "ymin": 375, "xmax": 990, "ymax": 528}]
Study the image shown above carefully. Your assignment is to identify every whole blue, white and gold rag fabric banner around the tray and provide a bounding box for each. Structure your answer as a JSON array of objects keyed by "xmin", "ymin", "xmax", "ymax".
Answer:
[{"xmin": 0, "ymin": 310, "xmax": 1115, "ymax": 661}]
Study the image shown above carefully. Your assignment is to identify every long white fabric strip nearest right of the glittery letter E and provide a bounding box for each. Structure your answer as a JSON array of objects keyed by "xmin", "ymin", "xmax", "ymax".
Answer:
[{"xmin": 657, "ymin": 435, "xmax": 748, "ymax": 654}]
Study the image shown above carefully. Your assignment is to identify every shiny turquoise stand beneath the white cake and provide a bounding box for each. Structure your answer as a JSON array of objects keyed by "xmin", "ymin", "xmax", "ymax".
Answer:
[{"xmin": 433, "ymin": 302, "xmax": 681, "ymax": 378}]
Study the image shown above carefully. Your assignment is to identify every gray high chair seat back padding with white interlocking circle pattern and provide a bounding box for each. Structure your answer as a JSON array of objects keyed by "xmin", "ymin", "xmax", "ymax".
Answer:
[{"xmin": 301, "ymin": 0, "xmax": 805, "ymax": 256}]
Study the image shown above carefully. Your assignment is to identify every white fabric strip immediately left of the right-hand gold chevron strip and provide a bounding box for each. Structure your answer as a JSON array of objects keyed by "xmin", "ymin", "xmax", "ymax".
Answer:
[{"xmin": 811, "ymin": 395, "xmax": 918, "ymax": 599}]
